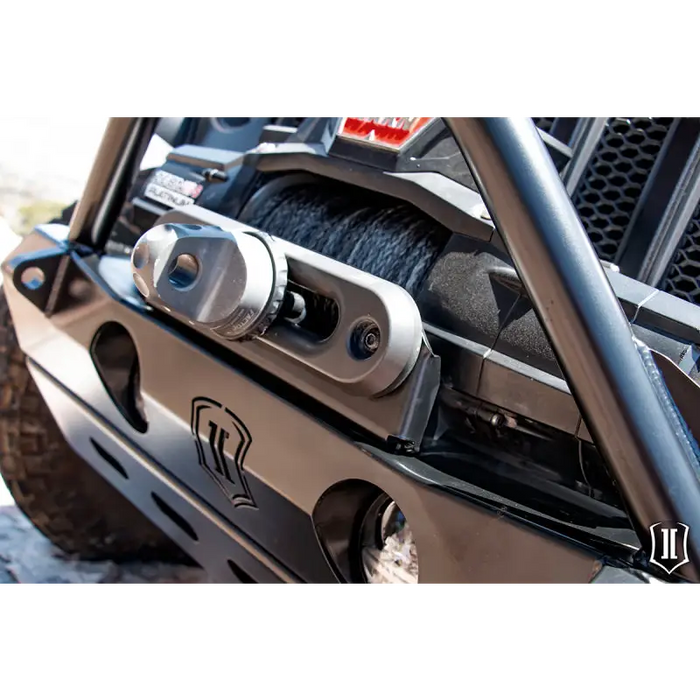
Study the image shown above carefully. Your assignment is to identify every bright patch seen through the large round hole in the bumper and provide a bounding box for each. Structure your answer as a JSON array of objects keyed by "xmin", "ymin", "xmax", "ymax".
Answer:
[{"xmin": 360, "ymin": 497, "xmax": 419, "ymax": 586}]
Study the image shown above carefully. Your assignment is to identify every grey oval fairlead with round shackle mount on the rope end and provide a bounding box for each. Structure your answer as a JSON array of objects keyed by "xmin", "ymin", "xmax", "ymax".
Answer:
[{"xmin": 131, "ymin": 205, "xmax": 427, "ymax": 404}]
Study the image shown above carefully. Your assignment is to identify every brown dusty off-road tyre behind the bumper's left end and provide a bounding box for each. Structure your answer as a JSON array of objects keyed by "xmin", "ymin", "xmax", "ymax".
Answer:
[{"xmin": 0, "ymin": 288, "xmax": 185, "ymax": 563}]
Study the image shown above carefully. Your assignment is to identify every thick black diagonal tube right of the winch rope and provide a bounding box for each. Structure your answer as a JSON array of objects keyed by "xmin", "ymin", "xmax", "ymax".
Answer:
[{"xmin": 444, "ymin": 115, "xmax": 700, "ymax": 581}]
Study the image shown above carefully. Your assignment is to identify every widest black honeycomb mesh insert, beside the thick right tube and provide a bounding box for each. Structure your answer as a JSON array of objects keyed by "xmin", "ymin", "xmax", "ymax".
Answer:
[{"xmin": 573, "ymin": 114, "xmax": 673, "ymax": 261}]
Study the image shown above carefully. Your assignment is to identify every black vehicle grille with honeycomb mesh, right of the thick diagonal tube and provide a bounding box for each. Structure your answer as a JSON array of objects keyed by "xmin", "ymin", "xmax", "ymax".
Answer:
[{"xmin": 531, "ymin": 114, "xmax": 700, "ymax": 304}]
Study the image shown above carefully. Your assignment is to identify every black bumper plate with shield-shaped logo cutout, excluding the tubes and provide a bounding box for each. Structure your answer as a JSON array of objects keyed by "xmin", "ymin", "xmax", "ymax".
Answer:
[{"xmin": 3, "ymin": 227, "xmax": 668, "ymax": 585}]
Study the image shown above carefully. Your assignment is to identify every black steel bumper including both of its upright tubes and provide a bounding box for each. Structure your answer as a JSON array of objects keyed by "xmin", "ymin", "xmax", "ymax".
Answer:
[{"xmin": 4, "ymin": 115, "xmax": 700, "ymax": 585}]
